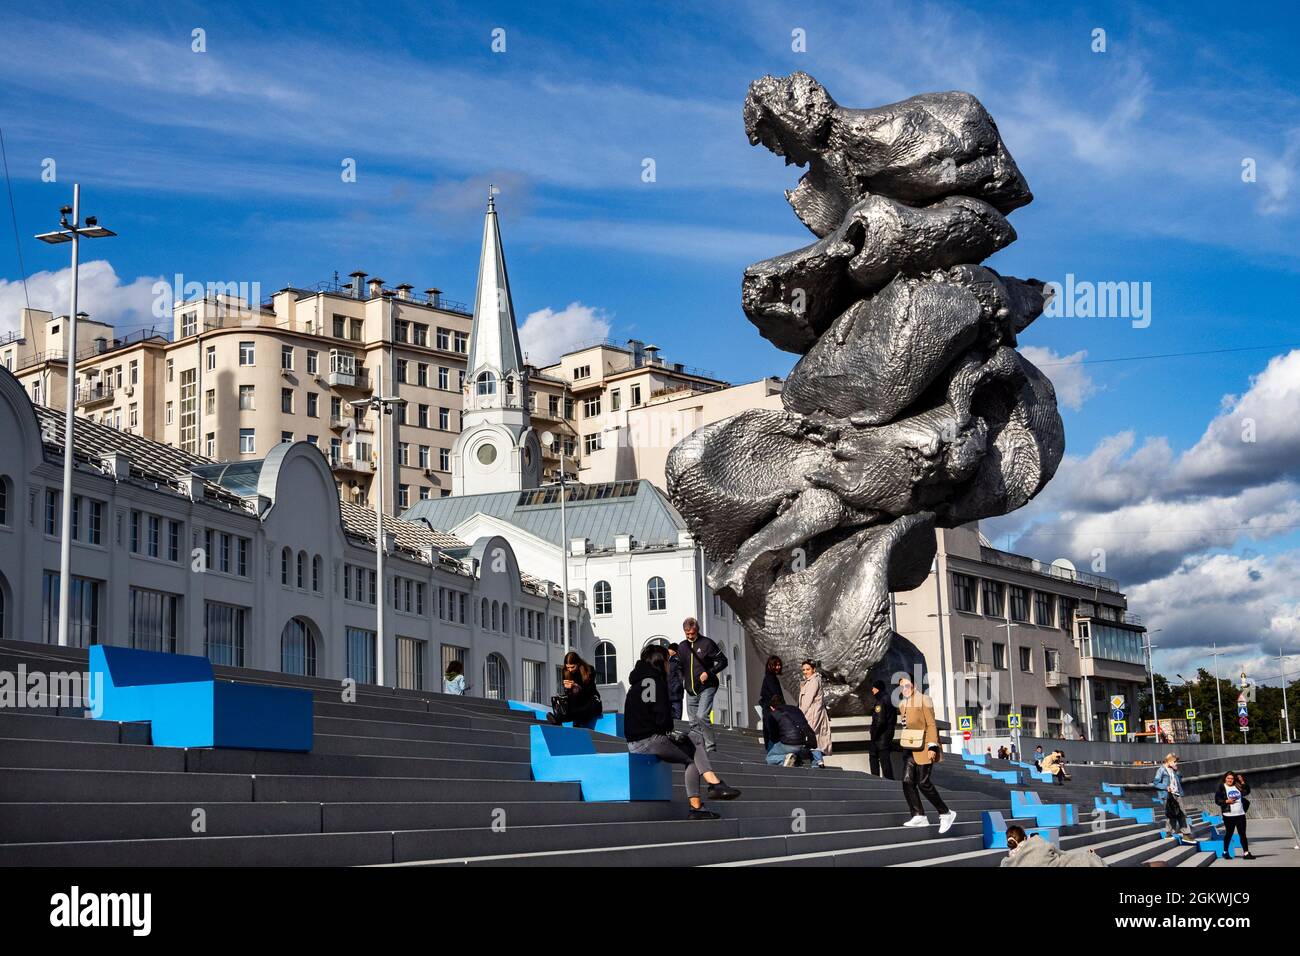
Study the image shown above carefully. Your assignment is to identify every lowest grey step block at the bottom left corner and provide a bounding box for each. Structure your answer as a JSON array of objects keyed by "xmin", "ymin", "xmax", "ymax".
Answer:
[{"xmin": 0, "ymin": 832, "xmax": 393, "ymax": 868}]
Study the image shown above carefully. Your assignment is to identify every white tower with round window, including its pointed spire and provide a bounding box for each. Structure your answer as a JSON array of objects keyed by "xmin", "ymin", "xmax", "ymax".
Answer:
[{"xmin": 451, "ymin": 190, "xmax": 542, "ymax": 496}]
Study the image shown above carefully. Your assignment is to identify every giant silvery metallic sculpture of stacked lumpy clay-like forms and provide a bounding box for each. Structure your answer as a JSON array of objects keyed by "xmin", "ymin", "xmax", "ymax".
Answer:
[{"xmin": 668, "ymin": 73, "xmax": 1065, "ymax": 714}]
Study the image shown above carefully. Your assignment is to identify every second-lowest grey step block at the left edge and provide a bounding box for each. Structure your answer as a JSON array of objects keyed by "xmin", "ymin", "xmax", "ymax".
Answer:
[{"xmin": 0, "ymin": 801, "xmax": 321, "ymax": 843}]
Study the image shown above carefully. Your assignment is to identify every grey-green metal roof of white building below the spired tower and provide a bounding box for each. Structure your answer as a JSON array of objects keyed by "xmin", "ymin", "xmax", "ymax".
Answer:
[{"xmin": 402, "ymin": 479, "xmax": 686, "ymax": 550}]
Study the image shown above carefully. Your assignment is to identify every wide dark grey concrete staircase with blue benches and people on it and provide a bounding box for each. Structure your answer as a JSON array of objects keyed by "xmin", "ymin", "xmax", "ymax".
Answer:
[{"xmin": 0, "ymin": 641, "xmax": 1190, "ymax": 866}]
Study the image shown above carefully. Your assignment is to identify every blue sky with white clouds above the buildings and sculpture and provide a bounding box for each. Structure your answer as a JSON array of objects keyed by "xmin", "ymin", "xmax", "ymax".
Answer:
[{"xmin": 0, "ymin": 3, "xmax": 1300, "ymax": 672}]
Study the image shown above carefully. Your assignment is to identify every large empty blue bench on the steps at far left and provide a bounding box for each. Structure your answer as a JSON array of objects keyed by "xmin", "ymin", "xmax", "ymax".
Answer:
[{"xmin": 90, "ymin": 644, "xmax": 312, "ymax": 752}]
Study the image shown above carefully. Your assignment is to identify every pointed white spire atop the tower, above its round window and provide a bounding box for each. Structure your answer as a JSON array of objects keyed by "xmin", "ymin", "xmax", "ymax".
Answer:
[{"xmin": 467, "ymin": 186, "xmax": 524, "ymax": 401}]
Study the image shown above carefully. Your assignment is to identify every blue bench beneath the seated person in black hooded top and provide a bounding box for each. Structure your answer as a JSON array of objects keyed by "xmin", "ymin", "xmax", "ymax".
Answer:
[{"xmin": 528, "ymin": 723, "xmax": 672, "ymax": 803}]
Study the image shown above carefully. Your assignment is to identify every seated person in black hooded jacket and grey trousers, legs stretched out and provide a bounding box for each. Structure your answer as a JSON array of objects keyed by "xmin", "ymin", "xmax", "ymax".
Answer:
[{"xmin": 623, "ymin": 645, "xmax": 740, "ymax": 819}]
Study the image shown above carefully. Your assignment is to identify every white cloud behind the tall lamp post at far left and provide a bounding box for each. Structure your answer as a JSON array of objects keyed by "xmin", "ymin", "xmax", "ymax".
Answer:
[{"xmin": 0, "ymin": 259, "xmax": 161, "ymax": 334}]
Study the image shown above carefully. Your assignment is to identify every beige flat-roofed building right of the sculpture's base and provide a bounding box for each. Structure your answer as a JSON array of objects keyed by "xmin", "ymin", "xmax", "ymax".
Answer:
[{"xmin": 893, "ymin": 524, "xmax": 1147, "ymax": 740}]
